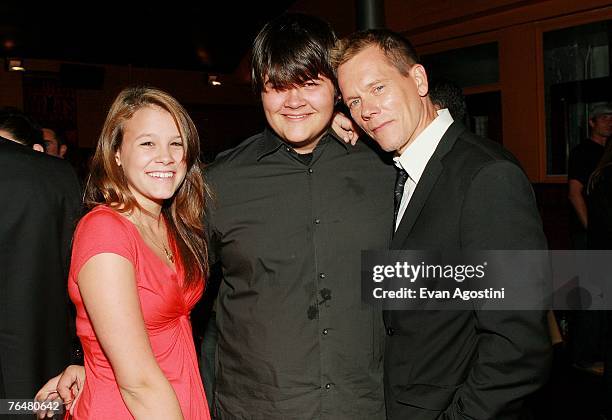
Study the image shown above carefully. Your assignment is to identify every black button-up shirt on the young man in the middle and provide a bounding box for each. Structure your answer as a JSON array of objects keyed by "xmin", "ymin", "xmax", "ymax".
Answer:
[{"xmin": 206, "ymin": 130, "xmax": 395, "ymax": 420}]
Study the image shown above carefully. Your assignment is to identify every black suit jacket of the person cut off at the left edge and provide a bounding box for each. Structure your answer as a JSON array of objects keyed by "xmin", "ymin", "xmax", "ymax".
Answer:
[{"xmin": 0, "ymin": 138, "xmax": 81, "ymax": 398}]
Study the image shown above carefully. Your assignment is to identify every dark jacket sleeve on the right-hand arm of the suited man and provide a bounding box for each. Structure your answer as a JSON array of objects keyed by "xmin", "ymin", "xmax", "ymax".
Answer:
[{"xmin": 443, "ymin": 161, "xmax": 551, "ymax": 420}]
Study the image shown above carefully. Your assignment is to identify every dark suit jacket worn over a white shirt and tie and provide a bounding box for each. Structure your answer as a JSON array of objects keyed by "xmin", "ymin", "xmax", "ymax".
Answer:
[{"xmin": 384, "ymin": 123, "xmax": 550, "ymax": 420}]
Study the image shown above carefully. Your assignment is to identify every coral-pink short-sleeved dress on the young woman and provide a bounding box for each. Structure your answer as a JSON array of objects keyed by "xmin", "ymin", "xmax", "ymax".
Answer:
[{"xmin": 68, "ymin": 206, "xmax": 210, "ymax": 420}]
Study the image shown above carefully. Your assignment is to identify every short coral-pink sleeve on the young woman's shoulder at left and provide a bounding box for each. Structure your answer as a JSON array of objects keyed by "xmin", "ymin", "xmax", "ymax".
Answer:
[{"xmin": 70, "ymin": 209, "xmax": 137, "ymax": 281}]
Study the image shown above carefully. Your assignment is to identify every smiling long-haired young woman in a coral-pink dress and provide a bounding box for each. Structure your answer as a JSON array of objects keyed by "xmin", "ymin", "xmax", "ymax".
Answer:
[{"xmin": 45, "ymin": 88, "xmax": 209, "ymax": 420}]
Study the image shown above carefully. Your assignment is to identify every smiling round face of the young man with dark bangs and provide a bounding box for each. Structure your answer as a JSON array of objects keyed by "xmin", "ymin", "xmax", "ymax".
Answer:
[{"xmin": 261, "ymin": 76, "xmax": 335, "ymax": 153}]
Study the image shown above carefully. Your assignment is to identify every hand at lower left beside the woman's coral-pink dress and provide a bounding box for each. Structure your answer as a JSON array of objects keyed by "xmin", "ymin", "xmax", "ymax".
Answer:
[{"xmin": 34, "ymin": 365, "xmax": 85, "ymax": 419}]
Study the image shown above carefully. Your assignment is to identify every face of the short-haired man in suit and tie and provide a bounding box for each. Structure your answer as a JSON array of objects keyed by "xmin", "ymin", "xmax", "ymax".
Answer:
[{"xmin": 338, "ymin": 46, "xmax": 435, "ymax": 154}]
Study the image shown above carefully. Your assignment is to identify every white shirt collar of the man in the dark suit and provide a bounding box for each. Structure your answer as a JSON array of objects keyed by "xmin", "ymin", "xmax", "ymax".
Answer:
[{"xmin": 393, "ymin": 108, "xmax": 453, "ymax": 184}]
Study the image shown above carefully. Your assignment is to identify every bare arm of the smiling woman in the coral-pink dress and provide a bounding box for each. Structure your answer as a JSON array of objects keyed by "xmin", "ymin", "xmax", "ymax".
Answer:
[{"xmin": 78, "ymin": 253, "xmax": 183, "ymax": 420}]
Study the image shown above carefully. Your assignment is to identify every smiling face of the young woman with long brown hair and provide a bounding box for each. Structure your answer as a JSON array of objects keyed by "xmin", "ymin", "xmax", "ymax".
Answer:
[{"xmin": 115, "ymin": 106, "xmax": 187, "ymax": 209}]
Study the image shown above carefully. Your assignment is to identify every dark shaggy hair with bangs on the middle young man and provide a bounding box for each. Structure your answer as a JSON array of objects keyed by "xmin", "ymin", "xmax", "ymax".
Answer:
[{"xmin": 251, "ymin": 13, "xmax": 336, "ymax": 93}]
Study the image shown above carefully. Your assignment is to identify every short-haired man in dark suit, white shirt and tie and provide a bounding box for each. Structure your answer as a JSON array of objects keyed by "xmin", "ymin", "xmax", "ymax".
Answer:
[{"xmin": 335, "ymin": 30, "xmax": 550, "ymax": 420}]
